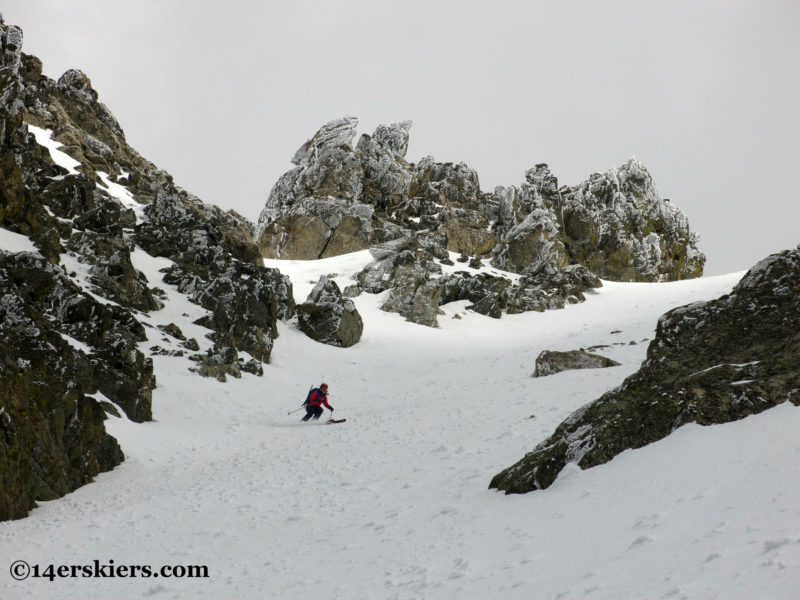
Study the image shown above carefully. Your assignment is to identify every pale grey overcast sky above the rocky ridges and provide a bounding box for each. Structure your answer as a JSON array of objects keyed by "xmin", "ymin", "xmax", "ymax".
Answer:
[{"xmin": 2, "ymin": 0, "xmax": 800, "ymax": 275}]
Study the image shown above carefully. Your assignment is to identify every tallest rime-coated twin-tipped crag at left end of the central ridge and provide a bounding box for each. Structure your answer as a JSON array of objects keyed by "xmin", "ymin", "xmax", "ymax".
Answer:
[{"xmin": 257, "ymin": 117, "xmax": 411, "ymax": 259}]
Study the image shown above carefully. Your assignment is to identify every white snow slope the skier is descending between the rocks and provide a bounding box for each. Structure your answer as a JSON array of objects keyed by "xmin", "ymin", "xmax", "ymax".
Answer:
[{"xmin": 0, "ymin": 252, "xmax": 800, "ymax": 600}]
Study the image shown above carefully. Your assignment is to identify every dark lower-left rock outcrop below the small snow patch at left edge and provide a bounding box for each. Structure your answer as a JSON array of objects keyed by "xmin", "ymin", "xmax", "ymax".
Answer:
[{"xmin": 0, "ymin": 252, "xmax": 125, "ymax": 520}]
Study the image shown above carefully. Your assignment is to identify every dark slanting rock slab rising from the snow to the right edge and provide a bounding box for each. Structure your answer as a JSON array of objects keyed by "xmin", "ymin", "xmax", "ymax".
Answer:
[{"xmin": 491, "ymin": 250, "xmax": 800, "ymax": 493}]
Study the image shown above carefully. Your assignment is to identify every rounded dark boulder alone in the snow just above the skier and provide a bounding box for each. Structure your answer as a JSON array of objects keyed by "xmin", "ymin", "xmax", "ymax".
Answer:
[{"xmin": 297, "ymin": 276, "xmax": 364, "ymax": 348}]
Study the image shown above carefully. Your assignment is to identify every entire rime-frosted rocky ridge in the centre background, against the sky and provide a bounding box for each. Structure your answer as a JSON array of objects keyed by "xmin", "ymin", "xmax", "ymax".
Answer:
[{"xmin": 256, "ymin": 117, "xmax": 705, "ymax": 326}]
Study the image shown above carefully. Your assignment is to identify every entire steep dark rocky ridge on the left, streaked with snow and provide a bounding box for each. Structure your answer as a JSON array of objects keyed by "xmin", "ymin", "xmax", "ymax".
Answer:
[{"xmin": 0, "ymin": 23, "xmax": 295, "ymax": 520}]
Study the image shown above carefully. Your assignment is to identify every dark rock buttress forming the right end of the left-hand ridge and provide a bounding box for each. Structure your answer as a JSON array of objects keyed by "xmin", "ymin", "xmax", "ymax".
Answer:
[{"xmin": 141, "ymin": 177, "xmax": 295, "ymax": 366}]
